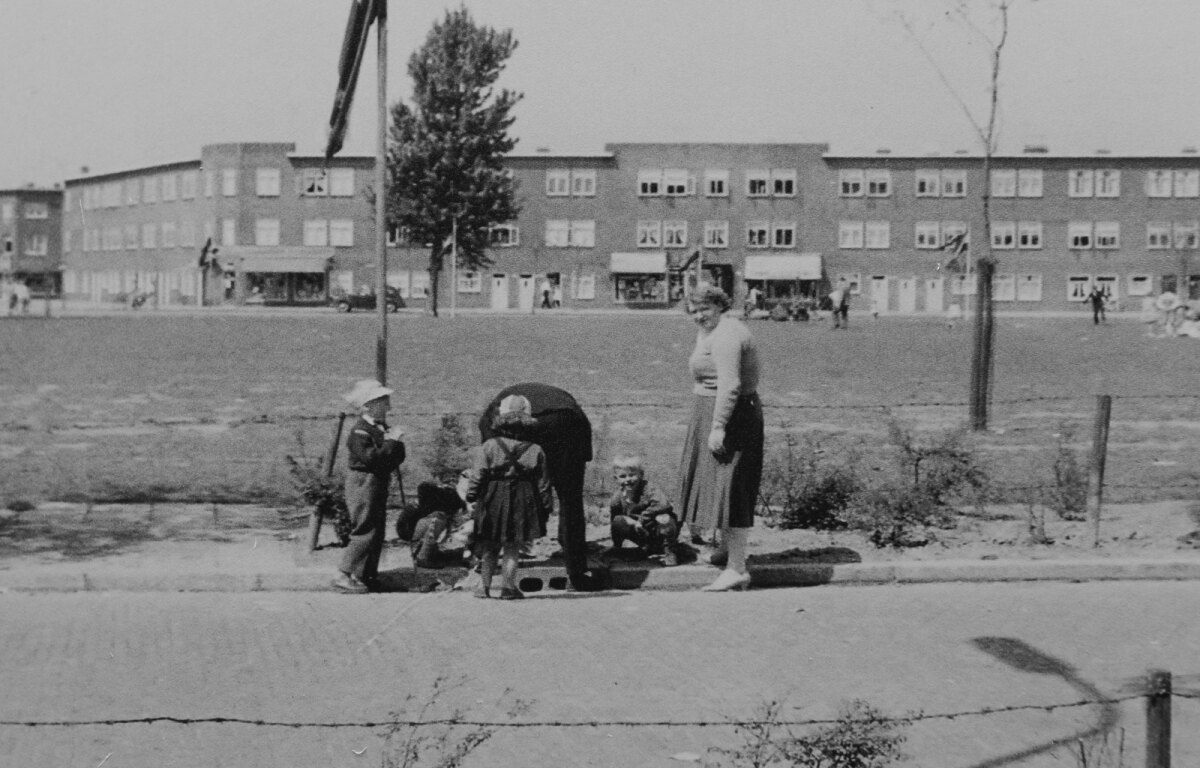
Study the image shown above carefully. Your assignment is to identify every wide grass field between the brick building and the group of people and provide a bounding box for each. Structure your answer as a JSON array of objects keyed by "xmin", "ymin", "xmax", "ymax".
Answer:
[{"xmin": 0, "ymin": 312, "xmax": 1200, "ymax": 505}]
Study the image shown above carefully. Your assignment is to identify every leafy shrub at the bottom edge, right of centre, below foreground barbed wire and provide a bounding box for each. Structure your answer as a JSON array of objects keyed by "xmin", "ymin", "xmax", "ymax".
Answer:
[{"xmin": 713, "ymin": 698, "xmax": 911, "ymax": 768}]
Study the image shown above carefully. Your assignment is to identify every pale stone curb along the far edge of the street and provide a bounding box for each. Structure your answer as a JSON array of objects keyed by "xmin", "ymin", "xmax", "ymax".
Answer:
[{"xmin": 0, "ymin": 558, "xmax": 1200, "ymax": 594}]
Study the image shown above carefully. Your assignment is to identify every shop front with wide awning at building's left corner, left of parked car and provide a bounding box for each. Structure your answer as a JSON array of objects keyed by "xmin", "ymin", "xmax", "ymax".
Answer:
[{"xmin": 222, "ymin": 246, "xmax": 334, "ymax": 306}]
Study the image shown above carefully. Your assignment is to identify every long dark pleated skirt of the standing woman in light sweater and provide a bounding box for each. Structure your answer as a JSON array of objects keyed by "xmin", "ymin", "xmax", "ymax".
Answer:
[{"xmin": 678, "ymin": 395, "xmax": 763, "ymax": 529}]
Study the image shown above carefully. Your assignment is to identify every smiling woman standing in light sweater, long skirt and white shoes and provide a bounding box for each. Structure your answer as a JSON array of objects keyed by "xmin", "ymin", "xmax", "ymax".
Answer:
[{"xmin": 679, "ymin": 286, "xmax": 762, "ymax": 592}]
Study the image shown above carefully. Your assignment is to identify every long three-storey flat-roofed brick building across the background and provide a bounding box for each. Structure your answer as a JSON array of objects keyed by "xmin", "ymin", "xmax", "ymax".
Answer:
[{"xmin": 61, "ymin": 144, "xmax": 1200, "ymax": 314}]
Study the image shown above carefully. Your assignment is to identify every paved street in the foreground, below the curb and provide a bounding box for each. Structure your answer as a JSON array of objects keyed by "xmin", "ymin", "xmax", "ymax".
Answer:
[{"xmin": 0, "ymin": 582, "xmax": 1200, "ymax": 768}]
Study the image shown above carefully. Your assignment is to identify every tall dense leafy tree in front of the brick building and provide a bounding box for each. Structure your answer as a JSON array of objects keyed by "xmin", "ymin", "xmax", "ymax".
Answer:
[{"xmin": 388, "ymin": 6, "xmax": 521, "ymax": 316}]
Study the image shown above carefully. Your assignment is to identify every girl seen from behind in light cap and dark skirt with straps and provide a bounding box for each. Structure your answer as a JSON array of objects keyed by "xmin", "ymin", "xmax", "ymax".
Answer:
[{"xmin": 467, "ymin": 395, "xmax": 553, "ymax": 600}]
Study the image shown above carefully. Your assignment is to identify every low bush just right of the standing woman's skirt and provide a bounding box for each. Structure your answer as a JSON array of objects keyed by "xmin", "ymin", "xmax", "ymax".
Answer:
[{"xmin": 758, "ymin": 425, "xmax": 862, "ymax": 530}]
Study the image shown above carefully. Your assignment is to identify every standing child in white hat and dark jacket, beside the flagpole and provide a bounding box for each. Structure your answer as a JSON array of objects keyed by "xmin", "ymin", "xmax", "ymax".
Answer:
[{"xmin": 332, "ymin": 379, "xmax": 404, "ymax": 593}]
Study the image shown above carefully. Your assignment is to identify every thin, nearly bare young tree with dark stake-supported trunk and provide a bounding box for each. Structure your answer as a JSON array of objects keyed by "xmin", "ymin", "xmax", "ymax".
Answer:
[{"xmin": 878, "ymin": 0, "xmax": 1016, "ymax": 431}]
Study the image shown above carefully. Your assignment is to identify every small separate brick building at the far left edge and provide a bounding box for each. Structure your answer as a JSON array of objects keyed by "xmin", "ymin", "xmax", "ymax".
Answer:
[{"xmin": 0, "ymin": 186, "xmax": 62, "ymax": 295}]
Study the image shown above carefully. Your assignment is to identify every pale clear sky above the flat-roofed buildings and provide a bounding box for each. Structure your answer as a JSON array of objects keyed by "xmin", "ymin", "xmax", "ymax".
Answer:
[{"xmin": 0, "ymin": 0, "xmax": 1200, "ymax": 188}]
